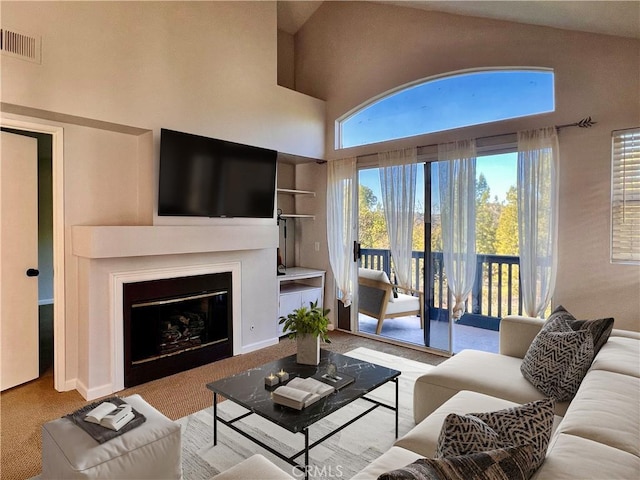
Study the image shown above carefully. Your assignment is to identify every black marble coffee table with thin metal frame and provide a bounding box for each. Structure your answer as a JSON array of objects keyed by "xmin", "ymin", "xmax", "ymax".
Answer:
[{"xmin": 207, "ymin": 350, "xmax": 400, "ymax": 478}]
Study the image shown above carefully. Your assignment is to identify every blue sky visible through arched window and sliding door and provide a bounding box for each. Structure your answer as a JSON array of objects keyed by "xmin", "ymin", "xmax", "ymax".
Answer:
[{"xmin": 350, "ymin": 69, "xmax": 555, "ymax": 213}]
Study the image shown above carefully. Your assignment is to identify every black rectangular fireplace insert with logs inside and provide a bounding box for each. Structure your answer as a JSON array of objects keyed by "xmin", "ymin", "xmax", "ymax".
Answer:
[{"xmin": 123, "ymin": 272, "xmax": 233, "ymax": 387}]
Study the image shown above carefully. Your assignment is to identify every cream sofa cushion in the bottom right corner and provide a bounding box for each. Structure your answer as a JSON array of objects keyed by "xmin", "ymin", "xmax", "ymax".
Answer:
[{"xmin": 531, "ymin": 434, "xmax": 640, "ymax": 480}]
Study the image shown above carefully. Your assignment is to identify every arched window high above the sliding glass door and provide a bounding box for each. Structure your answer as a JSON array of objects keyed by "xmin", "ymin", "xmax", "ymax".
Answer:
[{"xmin": 336, "ymin": 68, "xmax": 555, "ymax": 148}]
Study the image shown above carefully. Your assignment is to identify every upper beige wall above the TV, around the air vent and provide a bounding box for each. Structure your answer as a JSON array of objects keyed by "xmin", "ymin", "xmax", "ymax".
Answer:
[{"xmin": 1, "ymin": 2, "xmax": 324, "ymax": 157}]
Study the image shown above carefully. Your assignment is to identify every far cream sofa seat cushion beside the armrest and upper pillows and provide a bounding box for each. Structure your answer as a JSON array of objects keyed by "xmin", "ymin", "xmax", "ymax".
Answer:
[{"xmin": 413, "ymin": 350, "xmax": 569, "ymax": 423}]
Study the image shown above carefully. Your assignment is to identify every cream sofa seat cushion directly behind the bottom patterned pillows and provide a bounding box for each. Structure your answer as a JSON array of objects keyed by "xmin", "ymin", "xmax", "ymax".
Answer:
[{"xmin": 395, "ymin": 390, "xmax": 561, "ymax": 457}]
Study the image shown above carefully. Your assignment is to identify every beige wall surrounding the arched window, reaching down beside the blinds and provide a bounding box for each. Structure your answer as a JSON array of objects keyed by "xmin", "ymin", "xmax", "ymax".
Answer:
[{"xmin": 296, "ymin": 2, "xmax": 640, "ymax": 330}]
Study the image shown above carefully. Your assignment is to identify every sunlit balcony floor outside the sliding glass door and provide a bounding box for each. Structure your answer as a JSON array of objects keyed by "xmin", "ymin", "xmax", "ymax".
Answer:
[{"xmin": 358, "ymin": 313, "xmax": 498, "ymax": 353}]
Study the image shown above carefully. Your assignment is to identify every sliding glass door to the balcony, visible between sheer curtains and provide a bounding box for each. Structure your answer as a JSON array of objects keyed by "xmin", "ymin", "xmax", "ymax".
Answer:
[{"xmin": 354, "ymin": 153, "xmax": 521, "ymax": 353}]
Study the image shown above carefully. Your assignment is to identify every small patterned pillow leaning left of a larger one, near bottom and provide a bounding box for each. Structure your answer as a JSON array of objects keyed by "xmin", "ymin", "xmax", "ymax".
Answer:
[{"xmin": 435, "ymin": 413, "xmax": 504, "ymax": 458}]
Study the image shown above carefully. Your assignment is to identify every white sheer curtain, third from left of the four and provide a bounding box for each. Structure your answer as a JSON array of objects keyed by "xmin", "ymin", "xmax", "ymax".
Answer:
[{"xmin": 438, "ymin": 140, "xmax": 476, "ymax": 320}]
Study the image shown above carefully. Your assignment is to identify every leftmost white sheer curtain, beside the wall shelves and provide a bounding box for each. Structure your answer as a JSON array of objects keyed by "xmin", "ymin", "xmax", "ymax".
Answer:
[{"xmin": 327, "ymin": 158, "xmax": 358, "ymax": 306}]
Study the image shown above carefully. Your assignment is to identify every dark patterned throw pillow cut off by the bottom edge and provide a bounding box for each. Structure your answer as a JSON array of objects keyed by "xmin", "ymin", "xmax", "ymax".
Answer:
[{"xmin": 378, "ymin": 445, "xmax": 532, "ymax": 480}]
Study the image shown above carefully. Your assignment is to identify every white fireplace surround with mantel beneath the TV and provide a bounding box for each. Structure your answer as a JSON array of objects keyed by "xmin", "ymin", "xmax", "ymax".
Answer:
[{"xmin": 72, "ymin": 225, "xmax": 278, "ymax": 400}]
